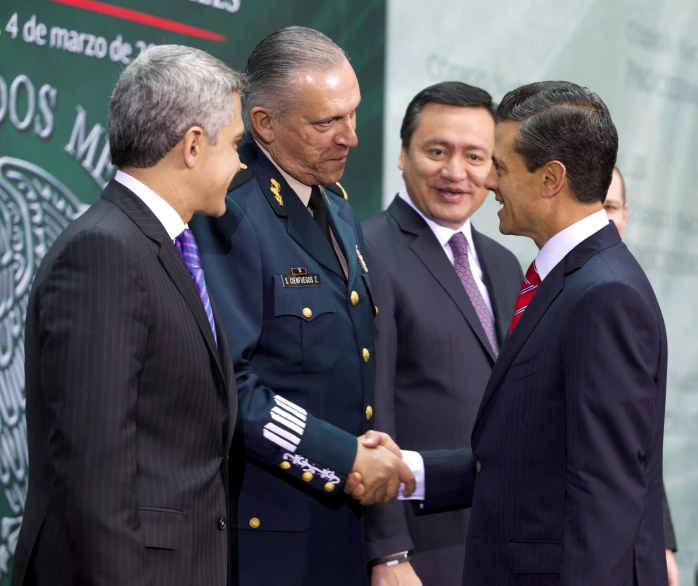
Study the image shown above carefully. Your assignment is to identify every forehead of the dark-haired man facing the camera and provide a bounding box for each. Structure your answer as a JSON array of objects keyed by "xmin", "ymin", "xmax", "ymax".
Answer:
[{"xmin": 413, "ymin": 103, "xmax": 494, "ymax": 143}]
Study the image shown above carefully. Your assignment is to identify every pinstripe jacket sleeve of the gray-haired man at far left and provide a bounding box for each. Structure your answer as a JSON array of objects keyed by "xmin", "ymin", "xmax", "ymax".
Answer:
[{"xmin": 38, "ymin": 231, "xmax": 148, "ymax": 586}]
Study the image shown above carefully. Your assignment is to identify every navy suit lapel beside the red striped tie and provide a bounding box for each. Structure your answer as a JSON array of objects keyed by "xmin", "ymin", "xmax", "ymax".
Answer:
[{"xmin": 473, "ymin": 224, "xmax": 621, "ymax": 430}]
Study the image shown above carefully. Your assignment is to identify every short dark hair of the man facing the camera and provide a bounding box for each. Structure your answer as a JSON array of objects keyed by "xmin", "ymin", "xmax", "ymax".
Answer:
[{"xmin": 400, "ymin": 81, "xmax": 494, "ymax": 150}]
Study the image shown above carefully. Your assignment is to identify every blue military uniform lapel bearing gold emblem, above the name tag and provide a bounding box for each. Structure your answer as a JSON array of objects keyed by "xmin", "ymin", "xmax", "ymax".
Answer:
[{"xmin": 244, "ymin": 138, "xmax": 344, "ymax": 278}]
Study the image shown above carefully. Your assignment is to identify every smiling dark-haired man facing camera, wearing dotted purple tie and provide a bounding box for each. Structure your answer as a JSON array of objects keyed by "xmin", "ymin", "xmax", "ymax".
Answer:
[{"xmin": 363, "ymin": 82, "xmax": 523, "ymax": 586}]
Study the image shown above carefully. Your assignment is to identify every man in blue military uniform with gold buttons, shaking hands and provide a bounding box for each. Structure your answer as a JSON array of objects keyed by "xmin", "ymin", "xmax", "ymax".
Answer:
[{"xmin": 191, "ymin": 27, "xmax": 413, "ymax": 586}]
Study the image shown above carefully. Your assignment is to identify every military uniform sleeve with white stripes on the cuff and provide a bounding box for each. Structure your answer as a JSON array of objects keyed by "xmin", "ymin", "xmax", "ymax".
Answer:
[{"xmin": 195, "ymin": 203, "xmax": 358, "ymax": 494}]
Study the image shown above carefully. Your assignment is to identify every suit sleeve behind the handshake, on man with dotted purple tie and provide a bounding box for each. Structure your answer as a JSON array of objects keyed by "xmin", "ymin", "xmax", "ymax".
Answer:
[{"xmin": 358, "ymin": 241, "xmax": 414, "ymax": 560}]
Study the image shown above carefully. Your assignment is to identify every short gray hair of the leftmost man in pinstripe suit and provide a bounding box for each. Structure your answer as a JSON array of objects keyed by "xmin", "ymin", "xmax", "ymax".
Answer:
[{"xmin": 109, "ymin": 45, "xmax": 245, "ymax": 168}]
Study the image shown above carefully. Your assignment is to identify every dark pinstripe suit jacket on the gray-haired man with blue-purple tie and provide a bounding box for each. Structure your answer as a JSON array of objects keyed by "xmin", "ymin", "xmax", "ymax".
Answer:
[{"xmin": 12, "ymin": 182, "xmax": 236, "ymax": 586}]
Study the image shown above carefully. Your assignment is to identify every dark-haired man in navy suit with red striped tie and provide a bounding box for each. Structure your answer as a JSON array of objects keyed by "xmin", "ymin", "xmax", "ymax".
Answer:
[{"xmin": 348, "ymin": 82, "xmax": 667, "ymax": 586}]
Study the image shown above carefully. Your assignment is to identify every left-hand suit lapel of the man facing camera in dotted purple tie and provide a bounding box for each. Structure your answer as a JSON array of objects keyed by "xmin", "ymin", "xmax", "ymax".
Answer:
[{"xmin": 388, "ymin": 196, "xmax": 495, "ymax": 363}]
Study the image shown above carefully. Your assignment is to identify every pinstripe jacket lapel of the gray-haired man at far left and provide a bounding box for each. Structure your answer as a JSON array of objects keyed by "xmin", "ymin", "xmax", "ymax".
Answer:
[{"xmin": 102, "ymin": 181, "xmax": 225, "ymax": 380}]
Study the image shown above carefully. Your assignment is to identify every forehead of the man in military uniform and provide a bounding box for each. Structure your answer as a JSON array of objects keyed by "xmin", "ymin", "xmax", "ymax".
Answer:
[{"xmin": 294, "ymin": 61, "xmax": 361, "ymax": 116}]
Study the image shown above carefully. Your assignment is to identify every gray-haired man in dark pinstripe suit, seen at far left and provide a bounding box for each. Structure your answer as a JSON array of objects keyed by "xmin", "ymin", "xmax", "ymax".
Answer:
[{"xmin": 12, "ymin": 45, "xmax": 244, "ymax": 586}]
